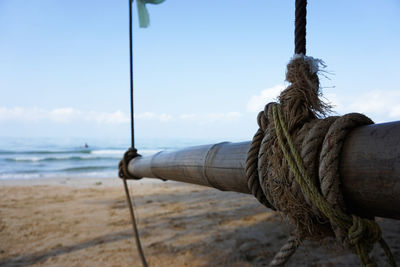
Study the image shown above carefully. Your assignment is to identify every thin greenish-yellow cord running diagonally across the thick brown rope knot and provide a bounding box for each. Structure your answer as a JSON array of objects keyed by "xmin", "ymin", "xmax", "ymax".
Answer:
[{"xmin": 272, "ymin": 104, "xmax": 396, "ymax": 266}]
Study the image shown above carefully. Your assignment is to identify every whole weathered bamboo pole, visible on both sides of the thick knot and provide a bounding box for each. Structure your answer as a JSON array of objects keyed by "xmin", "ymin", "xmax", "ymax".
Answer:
[{"xmin": 129, "ymin": 121, "xmax": 400, "ymax": 219}]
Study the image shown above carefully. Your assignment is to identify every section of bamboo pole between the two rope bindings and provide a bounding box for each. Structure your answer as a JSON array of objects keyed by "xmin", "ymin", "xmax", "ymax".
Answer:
[{"xmin": 129, "ymin": 142, "xmax": 250, "ymax": 194}]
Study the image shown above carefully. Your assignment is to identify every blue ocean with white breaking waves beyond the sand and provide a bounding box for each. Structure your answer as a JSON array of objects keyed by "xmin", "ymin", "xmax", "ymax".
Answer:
[{"xmin": 0, "ymin": 137, "xmax": 214, "ymax": 179}]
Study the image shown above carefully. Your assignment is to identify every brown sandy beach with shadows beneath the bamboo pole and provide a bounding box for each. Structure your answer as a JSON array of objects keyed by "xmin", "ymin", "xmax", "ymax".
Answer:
[{"xmin": 0, "ymin": 178, "xmax": 400, "ymax": 266}]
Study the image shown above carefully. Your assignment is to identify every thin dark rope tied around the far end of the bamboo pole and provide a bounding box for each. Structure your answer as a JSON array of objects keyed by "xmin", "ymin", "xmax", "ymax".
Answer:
[{"xmin": 119, "ymin": 0, "xmax": 147, "ymax": 267}]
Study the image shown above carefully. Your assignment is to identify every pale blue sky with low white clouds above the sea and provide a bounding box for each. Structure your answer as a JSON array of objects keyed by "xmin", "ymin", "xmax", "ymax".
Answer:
[{"xmin": 0, "ymin": 0, "xmax": 400, "ymax": 141}]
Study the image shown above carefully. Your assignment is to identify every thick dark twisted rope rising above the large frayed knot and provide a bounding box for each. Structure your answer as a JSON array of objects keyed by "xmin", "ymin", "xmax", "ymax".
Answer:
[{"xmin": 294, "ymin": 0, "xmax": 307, "ymax": 55}]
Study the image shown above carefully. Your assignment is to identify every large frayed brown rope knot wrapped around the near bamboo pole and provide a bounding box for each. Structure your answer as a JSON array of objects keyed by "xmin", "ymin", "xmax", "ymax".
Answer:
[{"xmin": 246, "ymin": 55, "xmax": 396, "ymax": 266}]
